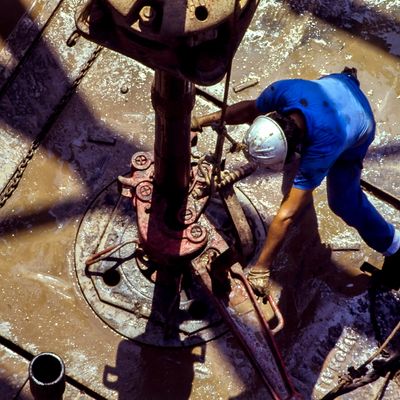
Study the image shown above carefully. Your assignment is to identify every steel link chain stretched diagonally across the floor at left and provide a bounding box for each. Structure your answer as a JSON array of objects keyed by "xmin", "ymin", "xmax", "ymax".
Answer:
[{"xmin": 0, "ymin": 46, "xmax": 103, "ymax": 209}]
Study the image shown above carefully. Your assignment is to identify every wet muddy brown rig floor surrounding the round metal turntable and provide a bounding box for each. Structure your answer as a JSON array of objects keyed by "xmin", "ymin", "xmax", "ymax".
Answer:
[{"xmin": 0, "ymin": 0, "xmax": 400, "ymax": 400}]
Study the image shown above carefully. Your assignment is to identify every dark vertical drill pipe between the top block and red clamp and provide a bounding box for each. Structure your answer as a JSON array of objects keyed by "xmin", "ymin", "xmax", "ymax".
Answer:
[{"xmin": 151, "ymin": 70, "xmax": 195, "ymax": 209}]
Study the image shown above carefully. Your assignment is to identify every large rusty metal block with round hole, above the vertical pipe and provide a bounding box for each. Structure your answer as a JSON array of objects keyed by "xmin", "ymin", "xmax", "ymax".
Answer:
[{"xmin": 76, "ymin": 0, "xmax": 259, "ymax": 85}]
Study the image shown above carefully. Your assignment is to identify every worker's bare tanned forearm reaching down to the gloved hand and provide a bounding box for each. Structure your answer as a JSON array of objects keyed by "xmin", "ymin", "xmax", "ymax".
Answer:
[{"xmin": 254, "ymin": 187, "xmax": 312, "ymax": 270}]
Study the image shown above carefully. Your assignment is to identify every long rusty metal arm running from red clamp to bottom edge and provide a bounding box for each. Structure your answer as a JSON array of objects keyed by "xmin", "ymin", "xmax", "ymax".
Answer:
[{"xmin": 192, "ymin": 228, "xmax": 299, "ymax": 400}]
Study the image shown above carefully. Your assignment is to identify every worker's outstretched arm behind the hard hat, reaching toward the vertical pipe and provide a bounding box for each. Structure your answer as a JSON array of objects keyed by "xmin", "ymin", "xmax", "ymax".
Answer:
[{"xmin": 192, "ymin": 100, "xmax": 262, "ymax": 129}]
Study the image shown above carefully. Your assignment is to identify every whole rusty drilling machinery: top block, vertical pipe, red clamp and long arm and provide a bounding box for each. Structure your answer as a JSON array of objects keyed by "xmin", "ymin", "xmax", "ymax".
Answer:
[{"xmin": 76, "ymin": 0, "xmax": 297, "ymax": 399}]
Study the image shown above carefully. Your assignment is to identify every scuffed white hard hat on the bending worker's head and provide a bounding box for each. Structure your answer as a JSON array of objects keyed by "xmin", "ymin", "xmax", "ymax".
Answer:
[{"xmin": 243, "ymin": 115, "xmax": 287, "ymax": 171}]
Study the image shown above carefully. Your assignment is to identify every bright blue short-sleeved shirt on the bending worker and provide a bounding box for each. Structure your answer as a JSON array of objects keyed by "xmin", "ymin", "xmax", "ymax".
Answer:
[{"xmin": 256, "ymin": 74, "xmax": 375, "ymax": 190}]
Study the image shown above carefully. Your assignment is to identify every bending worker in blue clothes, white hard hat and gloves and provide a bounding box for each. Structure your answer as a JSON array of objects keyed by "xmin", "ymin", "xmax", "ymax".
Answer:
[{"xmin": 192, "ymin": 67, "xmax": 400, "ymax": 296}]
